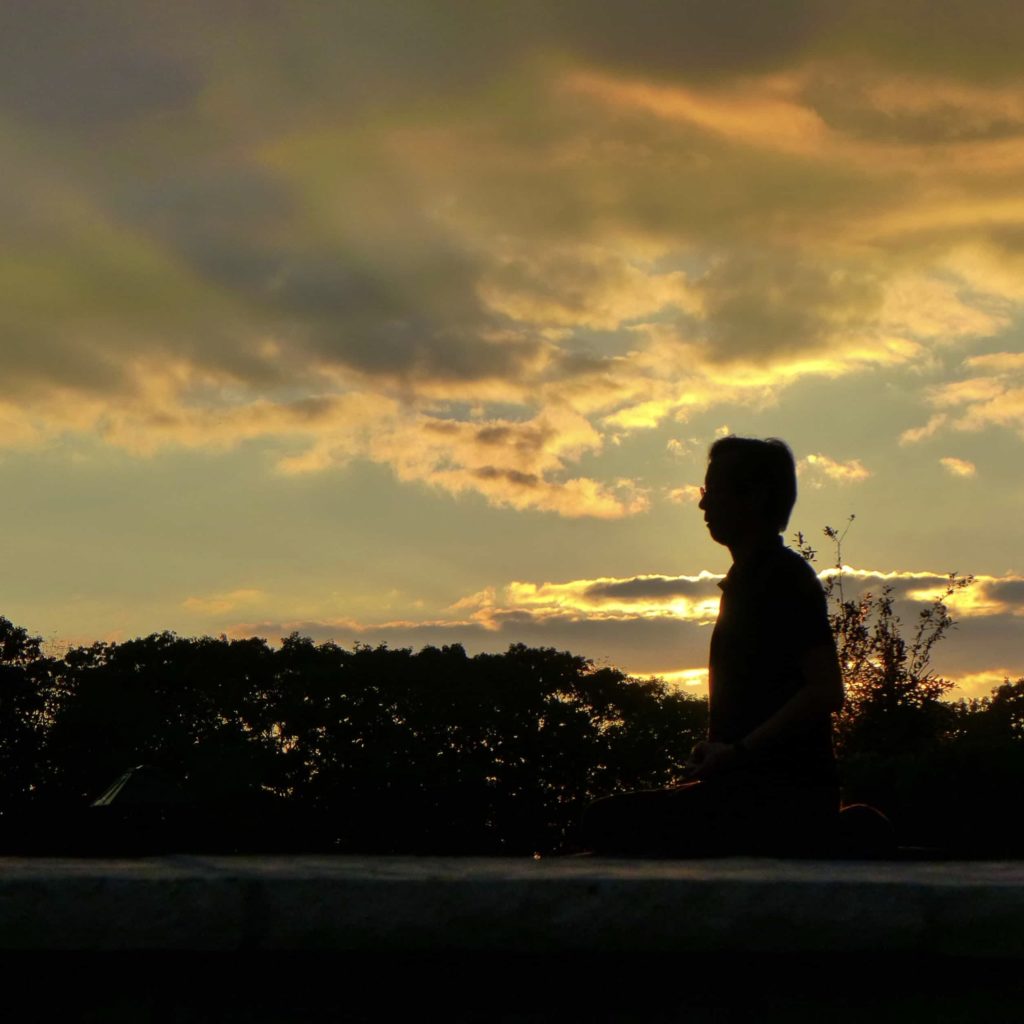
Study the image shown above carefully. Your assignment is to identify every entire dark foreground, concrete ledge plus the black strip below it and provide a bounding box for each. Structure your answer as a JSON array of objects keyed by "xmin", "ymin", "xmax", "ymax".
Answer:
[{"xmin": 0, "ymin": 855, "xmax": 1024, "ymax": 1024}]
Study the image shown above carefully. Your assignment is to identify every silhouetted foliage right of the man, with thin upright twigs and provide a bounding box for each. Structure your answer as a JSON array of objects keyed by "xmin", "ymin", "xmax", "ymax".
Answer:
[{"xmin": 796, "ymin": 516, "xmax": 1024, "ymax": 854}]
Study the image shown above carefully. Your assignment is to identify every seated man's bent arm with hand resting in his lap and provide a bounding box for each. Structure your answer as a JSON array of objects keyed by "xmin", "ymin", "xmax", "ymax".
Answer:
[{"xmin": 686, "ymin": 643, "xmax": 843, "ymax": 778}]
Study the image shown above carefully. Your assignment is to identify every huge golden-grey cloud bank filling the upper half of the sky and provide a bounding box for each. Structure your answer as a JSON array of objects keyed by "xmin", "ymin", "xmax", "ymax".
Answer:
[{"xmin": 6, "ymin": 0, "xmax": 1024, "ymax": 519}]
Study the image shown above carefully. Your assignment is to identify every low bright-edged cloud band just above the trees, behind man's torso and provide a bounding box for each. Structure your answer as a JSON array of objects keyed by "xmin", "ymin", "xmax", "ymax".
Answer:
[{"xmin": 216, "ymin": 566, "xmax": 1024, "ymax": 695}]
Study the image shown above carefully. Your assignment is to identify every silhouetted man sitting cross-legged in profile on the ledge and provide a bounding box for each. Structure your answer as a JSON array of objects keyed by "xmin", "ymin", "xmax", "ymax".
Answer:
[{"xmin": 582, "ymin": 437, "xmax": 843, "ymax": 856}]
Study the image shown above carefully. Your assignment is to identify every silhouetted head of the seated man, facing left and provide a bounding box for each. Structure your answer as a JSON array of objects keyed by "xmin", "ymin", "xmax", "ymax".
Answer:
[{"xmin": 700, "ymin": 436, "xmax": 797, "ymax": 545}]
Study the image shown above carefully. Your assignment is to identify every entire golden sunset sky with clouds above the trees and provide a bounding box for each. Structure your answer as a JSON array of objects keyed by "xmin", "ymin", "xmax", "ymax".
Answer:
[{"xmin": 0, "ymin": 0, "xmax": 1024, "ymax": 695}]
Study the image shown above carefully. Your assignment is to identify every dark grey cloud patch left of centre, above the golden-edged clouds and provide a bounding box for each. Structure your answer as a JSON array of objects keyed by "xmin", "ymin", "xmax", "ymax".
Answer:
[{"xmin": 108, "ymin": 164, "xmax": 538, "ymax": 380}]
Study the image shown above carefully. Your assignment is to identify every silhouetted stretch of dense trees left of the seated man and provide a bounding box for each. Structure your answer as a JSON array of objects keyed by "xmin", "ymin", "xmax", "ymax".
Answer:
[{"xmin": 0, "ymin": 621, "xmax": 707, "ymax": 852}]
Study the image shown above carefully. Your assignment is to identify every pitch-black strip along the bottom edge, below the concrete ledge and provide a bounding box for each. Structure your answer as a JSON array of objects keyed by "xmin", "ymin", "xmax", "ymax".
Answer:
[{"xmin": 0, "ymin": 952, "xmax": 1024, "ymax": 1024}]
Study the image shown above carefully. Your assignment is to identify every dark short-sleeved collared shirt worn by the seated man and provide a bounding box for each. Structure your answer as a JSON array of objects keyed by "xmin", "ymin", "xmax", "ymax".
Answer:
[{"xmin": 709, "ymin": 538, "xmax": 837, "ymax": 787}]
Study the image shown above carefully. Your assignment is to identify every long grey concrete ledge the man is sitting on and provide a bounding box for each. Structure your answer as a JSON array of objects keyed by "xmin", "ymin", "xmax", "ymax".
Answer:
[{"xmin": 0, "ymin": 856, "xmax": 1024, "ymax": 958}]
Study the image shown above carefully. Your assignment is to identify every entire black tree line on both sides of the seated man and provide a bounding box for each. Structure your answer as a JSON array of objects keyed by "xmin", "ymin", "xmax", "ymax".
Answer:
[{"xmin": 0, "ymin": 537, "xmax": 1024, "ymax": 855}]
